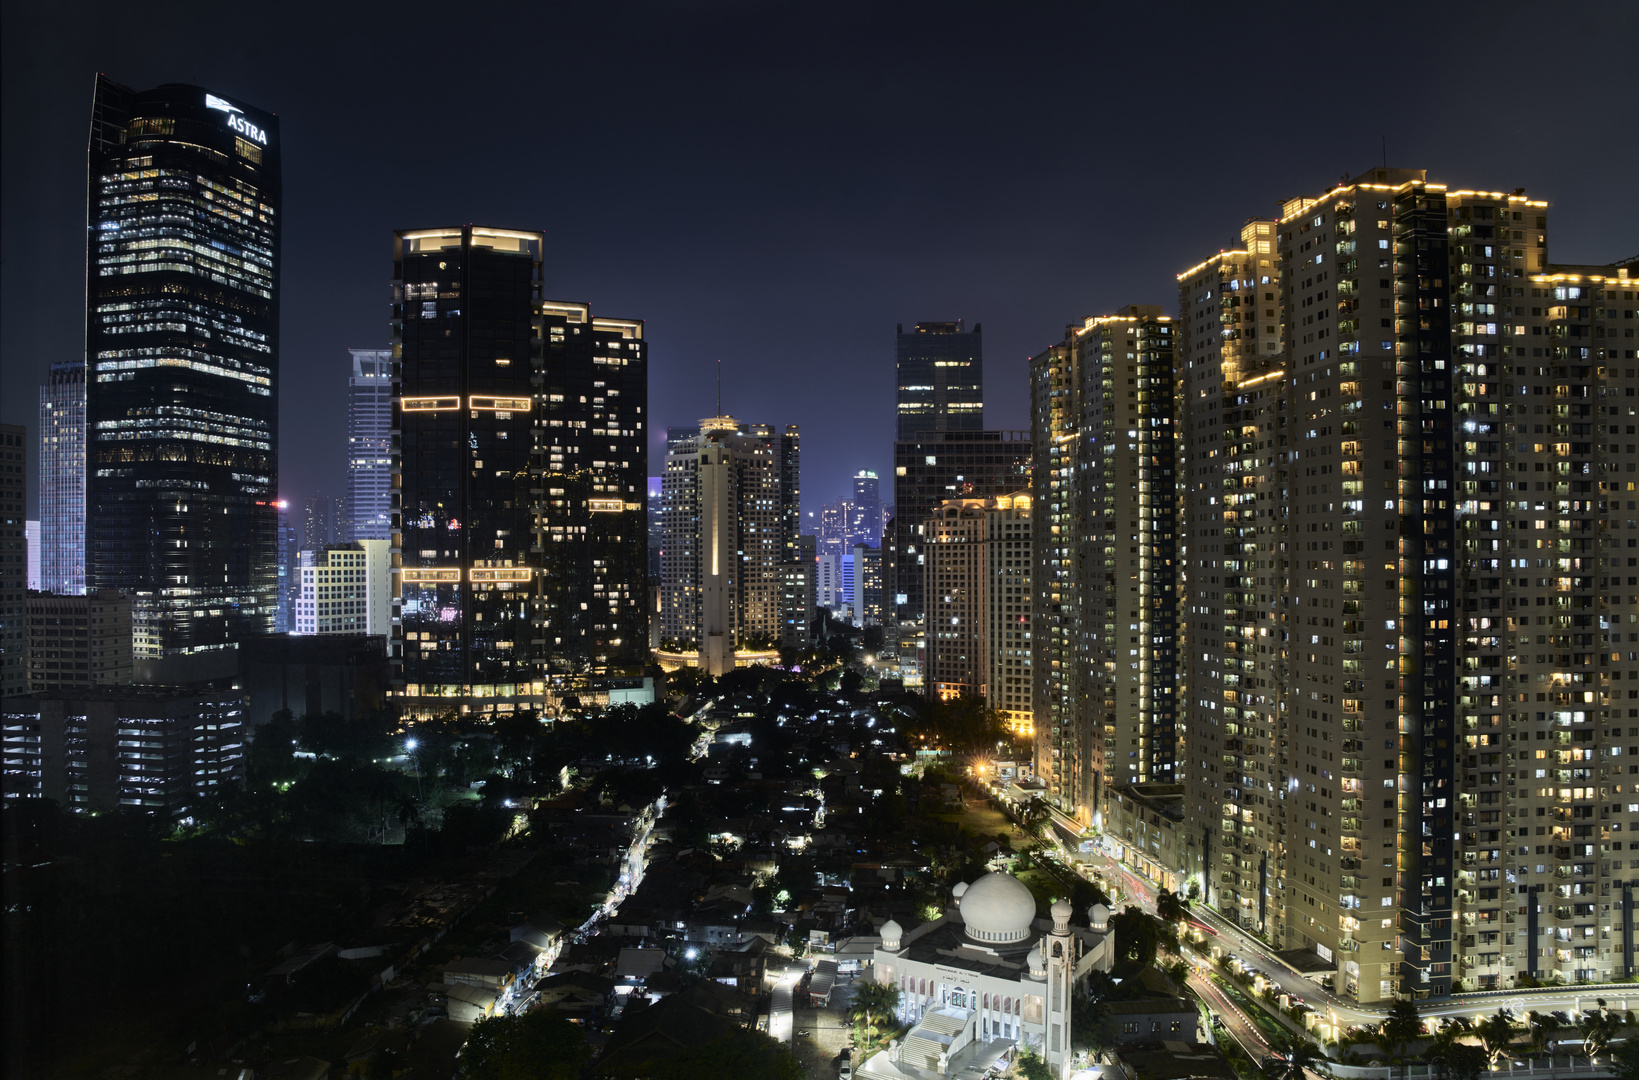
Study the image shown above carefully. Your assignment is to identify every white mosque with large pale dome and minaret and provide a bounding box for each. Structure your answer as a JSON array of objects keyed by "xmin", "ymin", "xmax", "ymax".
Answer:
[{"xmin": 874, "ymin": 874, "xmax": 1115, "ymax": 1077}]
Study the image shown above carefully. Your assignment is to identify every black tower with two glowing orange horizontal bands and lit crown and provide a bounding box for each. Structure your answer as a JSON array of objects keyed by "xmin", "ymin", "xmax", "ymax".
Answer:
[{"xmin": 393, "ymin": 226, "xmax": 543, "ymax": 713}]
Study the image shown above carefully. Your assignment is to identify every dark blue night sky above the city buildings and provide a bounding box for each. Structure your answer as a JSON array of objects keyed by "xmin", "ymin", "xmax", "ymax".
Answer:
[{"xmin": 0, "ymin": 0, "xmax": 1639, "ymax": 516}]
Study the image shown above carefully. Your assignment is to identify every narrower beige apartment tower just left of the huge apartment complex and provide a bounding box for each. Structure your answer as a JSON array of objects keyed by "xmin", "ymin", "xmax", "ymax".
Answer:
[{"xmin": 1031, "ymin": 305, "xmax": 1178, "ymax": 821}]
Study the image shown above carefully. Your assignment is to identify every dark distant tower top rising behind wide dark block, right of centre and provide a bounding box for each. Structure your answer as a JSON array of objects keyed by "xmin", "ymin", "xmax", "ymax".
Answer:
[{"xmin": 898, "ymin": 320, "xmax": 985, "ymax": 442}]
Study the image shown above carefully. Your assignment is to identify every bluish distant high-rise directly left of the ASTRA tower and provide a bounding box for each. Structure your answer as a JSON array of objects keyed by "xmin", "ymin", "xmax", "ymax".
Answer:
[{"xmin": 39, "ymin": 359, "xmax": 85, "ymax": 597}]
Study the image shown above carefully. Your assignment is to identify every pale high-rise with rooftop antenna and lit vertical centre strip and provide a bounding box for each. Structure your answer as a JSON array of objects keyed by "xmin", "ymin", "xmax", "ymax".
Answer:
[{"xmin": 661, "ymin": 416, "xmax": 800, "ymax": 675}]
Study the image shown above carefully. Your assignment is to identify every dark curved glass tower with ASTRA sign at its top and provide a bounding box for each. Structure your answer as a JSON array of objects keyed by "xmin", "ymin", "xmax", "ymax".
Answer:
[{"xmin": 85, "ymin": 75, "xmax": 280, "ymax": 657}]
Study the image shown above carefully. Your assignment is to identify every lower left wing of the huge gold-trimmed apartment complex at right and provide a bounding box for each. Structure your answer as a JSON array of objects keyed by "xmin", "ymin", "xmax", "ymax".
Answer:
[{"xmin": 1177, "ymin": 220, "xmax": 1292, "ymax": 928}]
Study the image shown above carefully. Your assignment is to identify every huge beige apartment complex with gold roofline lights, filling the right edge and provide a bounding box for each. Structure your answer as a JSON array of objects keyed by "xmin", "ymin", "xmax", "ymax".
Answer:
[{"xmin": 1178, "ymin": 169, "xmax": 1639, "ymax": 1001}]
